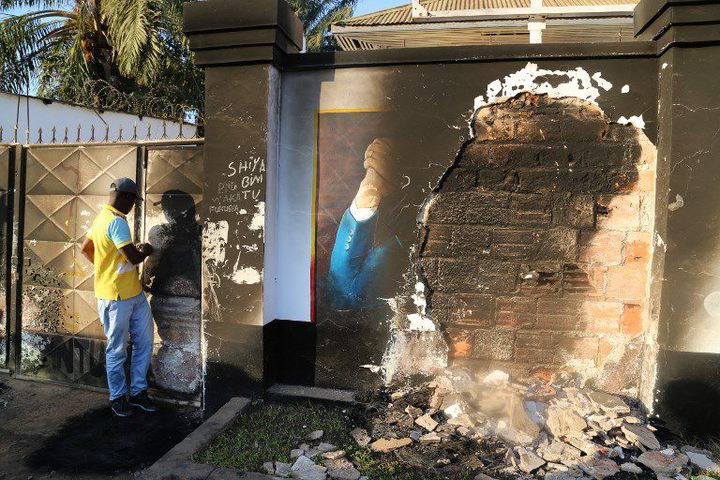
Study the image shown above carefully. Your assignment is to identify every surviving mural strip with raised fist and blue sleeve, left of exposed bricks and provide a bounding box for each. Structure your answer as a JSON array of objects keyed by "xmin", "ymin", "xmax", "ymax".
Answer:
[{"xmin": 312, "ymin": 109, "xmax": 444, "ymax": 386}]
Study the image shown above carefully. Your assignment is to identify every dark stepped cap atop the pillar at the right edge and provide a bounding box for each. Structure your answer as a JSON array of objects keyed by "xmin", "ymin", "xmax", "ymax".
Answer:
[{"xmin": 634, "ymin": 0, "xmax": 720, "ymax": 49}]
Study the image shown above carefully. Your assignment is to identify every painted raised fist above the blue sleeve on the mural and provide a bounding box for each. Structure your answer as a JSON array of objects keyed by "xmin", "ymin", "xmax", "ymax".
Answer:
[{"xmin": 355, "ymin": 138, "xmax": 397, "ymax": 208}]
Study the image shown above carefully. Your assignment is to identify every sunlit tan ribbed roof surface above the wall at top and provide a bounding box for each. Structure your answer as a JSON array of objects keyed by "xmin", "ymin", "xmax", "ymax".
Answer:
[{"xmin": 338, "ymin": 0, "xmax": 639, "ymax": 26}]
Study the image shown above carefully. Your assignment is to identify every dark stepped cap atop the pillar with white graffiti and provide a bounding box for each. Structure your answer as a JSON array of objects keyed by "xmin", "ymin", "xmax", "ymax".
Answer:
[{"xmin": 183, "ymin": 0, "xmax": 304, "ymax": 66}]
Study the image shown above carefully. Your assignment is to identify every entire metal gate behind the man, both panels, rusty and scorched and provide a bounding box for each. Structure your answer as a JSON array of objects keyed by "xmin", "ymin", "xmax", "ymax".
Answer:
[{"xmin": 9, "ymin": 140, "xmax": 202, "ymax": 400}]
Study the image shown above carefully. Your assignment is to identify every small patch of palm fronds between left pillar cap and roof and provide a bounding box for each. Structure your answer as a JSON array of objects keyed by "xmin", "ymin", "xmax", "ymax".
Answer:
[{"xmin": 288, "ymin": 0, "xmax": 357, "ymax": 51}]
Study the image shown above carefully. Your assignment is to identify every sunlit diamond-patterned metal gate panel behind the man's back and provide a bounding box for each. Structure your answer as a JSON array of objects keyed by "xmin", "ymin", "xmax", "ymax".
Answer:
[{"xmin": 21, "ymin": 145, "xmax": 137, "ymax": 386}]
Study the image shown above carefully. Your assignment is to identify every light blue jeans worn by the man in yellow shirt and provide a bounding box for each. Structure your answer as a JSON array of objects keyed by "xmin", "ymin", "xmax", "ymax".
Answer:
[{"xmin": 98, "ymin": 293, "xmax": 154, "ymax": 401}]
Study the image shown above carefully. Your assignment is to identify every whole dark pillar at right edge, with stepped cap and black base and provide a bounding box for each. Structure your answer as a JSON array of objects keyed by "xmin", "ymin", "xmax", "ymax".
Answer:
[{"xmin": 635, "ymin": 0, "xmax": 720, "ymax": 433}]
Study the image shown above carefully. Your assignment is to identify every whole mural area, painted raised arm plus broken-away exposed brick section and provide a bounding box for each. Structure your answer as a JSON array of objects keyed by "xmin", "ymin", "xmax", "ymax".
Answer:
[{"xmin": 313, "ymin": 64, "xmax": 657, "ymax": 402}]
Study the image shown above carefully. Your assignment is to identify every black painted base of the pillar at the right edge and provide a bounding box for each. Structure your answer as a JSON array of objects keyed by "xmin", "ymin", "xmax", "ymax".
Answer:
[{"xmin": 655, "ymin": 350, "xmax": 720, "ymax": 440}]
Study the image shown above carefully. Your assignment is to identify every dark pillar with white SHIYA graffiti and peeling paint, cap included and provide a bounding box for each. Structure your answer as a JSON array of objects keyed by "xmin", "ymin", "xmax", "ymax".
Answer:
[{"xmin": 179, "ymin": 0, "xmax": 303, "ymax": 411}]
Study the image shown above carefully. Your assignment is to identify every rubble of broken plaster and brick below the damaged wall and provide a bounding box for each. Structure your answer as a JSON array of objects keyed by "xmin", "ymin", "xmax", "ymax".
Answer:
[{"xmin": 256, "ymin": 371, "xmax": 720, "ymax": 480}]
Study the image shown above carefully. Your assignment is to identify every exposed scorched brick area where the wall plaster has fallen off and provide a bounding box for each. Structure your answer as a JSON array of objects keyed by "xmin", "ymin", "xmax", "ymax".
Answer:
[{"xmin": 419, "ymin": 93, "xmax": 655, "ymax": 396}]
